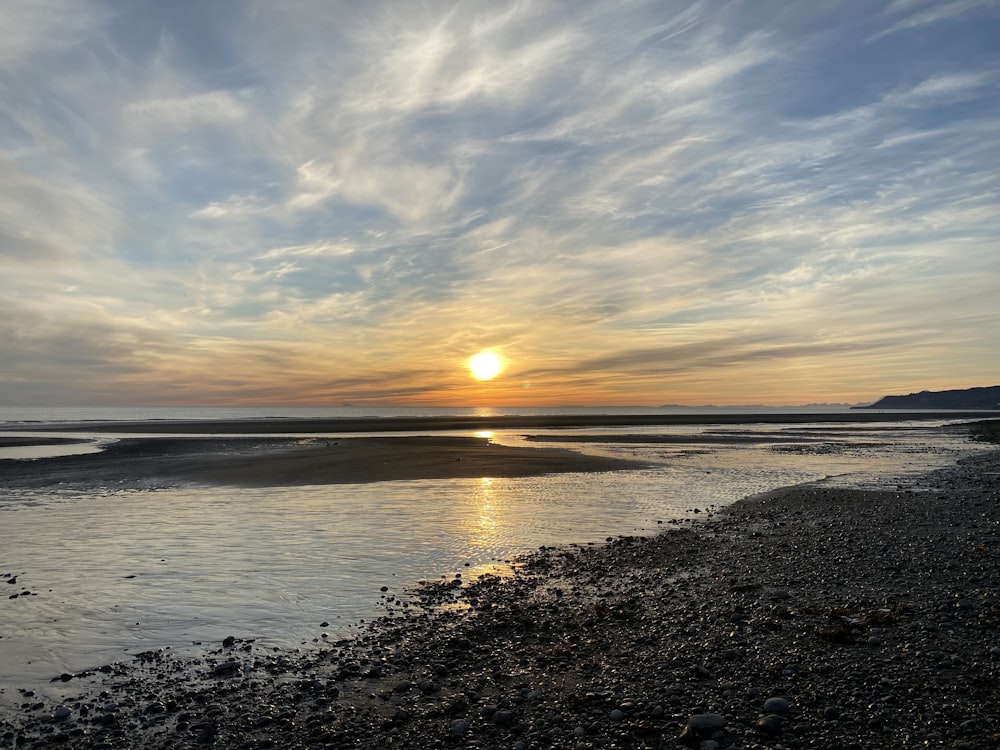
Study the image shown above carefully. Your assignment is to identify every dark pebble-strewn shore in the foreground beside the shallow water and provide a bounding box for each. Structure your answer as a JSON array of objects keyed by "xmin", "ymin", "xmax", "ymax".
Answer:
[{"xmin": 0, "ymin": 440, "xmax": 1000, "ymax": 750}]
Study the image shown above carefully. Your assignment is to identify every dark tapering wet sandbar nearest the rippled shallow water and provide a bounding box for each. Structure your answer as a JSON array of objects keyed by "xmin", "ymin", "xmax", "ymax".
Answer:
[{"xmin": 0, "ymin": 436, "xmax": 642, "ymax": 489}]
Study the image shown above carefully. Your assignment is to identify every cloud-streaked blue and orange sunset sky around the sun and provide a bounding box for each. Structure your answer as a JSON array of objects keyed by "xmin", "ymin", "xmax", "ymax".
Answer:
[{"xmin": 0, "ymin": 0, "xmax": 1000, "ymax": 406}]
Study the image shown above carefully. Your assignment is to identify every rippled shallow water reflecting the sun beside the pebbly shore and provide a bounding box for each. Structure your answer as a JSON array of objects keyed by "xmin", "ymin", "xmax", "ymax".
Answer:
[{"xmin": 0, "ymin": 425, "xmax": 977, "ymax": 700}]
